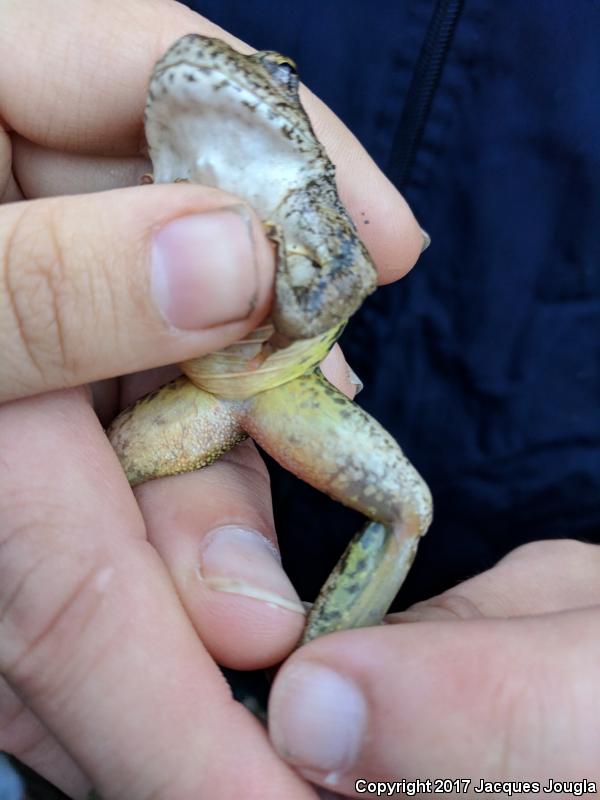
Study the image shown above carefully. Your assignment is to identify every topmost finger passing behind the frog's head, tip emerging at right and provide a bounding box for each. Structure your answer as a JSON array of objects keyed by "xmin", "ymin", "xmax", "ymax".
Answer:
[{"xmin": 0, "ymin": 0, "xmax": 424, "ymax": 283}]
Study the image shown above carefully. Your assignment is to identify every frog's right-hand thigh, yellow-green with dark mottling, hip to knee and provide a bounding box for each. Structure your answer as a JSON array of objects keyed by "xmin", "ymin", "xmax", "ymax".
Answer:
[{"xmin": 243, "ymin": 370, "xmax": 431, "ymax": 531}]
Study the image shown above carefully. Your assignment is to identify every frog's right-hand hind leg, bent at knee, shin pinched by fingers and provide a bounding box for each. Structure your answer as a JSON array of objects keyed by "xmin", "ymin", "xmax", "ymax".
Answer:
[{"xmin": 243, "ymin": 370, "xmax": 431, "ymax": 641}]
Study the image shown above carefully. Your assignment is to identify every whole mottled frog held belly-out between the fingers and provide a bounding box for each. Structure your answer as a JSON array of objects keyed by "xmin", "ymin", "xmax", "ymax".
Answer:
[{"xmin": 109, "ymin": 35, "xmax": 431, "ymax": 641}]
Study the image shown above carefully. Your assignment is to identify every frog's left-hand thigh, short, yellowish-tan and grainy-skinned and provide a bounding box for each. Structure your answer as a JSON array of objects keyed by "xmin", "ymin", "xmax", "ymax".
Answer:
[{"xmin": 108, "ymin": 378, "xmax": 246, "ymax": 486}]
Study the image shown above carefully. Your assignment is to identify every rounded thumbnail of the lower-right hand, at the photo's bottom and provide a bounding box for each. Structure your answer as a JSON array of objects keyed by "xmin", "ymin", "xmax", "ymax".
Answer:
[{"xmin": 269, "ymin": 662, "xmax": 367, "ymax": 773}]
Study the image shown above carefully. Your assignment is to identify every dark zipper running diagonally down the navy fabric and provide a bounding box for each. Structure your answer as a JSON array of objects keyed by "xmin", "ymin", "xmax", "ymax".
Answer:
[{"xmin": 388, "ymin": 0, "xmax": 464, "ymax": 189}]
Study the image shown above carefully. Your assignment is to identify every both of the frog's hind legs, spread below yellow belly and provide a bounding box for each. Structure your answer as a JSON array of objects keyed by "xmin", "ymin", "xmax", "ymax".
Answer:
[{"xmin": 109, "ymin": 368, "xmax": 431, "ymax": 642}]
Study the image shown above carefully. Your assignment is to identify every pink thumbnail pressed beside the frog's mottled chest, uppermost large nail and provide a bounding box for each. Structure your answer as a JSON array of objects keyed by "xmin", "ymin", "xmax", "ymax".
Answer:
[{"xmin": 151, "ymin": 206, "xmax": 257, "ymax": 330}]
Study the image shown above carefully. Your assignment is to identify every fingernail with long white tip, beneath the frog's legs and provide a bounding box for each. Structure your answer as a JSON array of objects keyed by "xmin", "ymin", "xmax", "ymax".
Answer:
[{"xmin": 199, "ymin": 526, "xmax": 305, "ymax": 615}]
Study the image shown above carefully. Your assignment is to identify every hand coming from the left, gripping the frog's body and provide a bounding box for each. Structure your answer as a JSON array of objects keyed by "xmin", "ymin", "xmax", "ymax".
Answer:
[{"xmin": 0, "ymin": 0, "xmax": 422, "ymax": 800}]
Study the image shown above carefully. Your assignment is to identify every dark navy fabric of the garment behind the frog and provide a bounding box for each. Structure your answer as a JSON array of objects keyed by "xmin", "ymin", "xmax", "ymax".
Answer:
[{"xmin": 190, "ymin": 0, "xmax": 600, "ymax": 607}]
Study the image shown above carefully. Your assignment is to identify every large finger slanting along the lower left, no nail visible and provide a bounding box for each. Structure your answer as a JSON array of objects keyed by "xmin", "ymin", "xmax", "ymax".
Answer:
[{"xmin": 0, "ymin": 392, "xmax": 313, "ymax": 800}]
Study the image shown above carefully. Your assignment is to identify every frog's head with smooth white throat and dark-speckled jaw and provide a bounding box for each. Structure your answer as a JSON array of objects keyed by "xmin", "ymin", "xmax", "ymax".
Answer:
[{"xmin": 146, "ymin": 34, "xmax": 328, "ymax": 219}]
